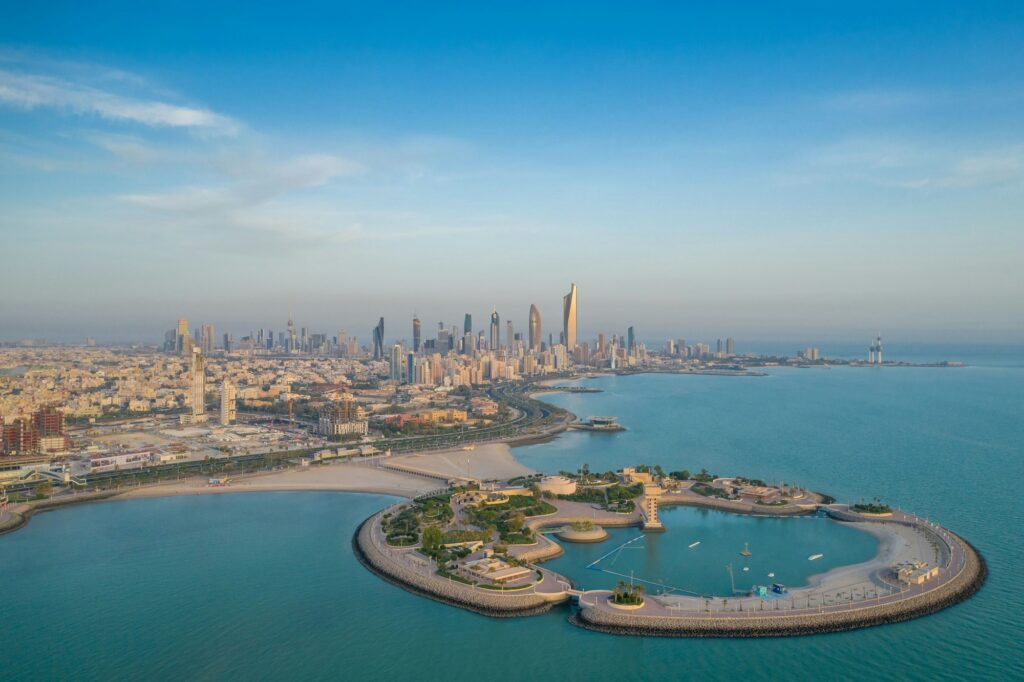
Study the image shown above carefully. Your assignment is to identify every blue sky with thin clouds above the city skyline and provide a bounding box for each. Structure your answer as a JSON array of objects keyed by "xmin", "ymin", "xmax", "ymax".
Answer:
[{"xmin": 0, "ymin": 2, "xmax": 1024, "ymax": 340}]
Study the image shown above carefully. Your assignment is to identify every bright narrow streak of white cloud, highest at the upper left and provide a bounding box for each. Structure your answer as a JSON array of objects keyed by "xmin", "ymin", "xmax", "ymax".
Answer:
[{"xmin": 0, "ymin": 70, "xmax": 241, "ymax": 135}]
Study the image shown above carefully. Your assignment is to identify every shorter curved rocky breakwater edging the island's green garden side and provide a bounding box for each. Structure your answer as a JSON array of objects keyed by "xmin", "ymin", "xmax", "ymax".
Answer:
[{"xmin": 352, "ymin": 513, "xmax": 568, "ymax": 617}]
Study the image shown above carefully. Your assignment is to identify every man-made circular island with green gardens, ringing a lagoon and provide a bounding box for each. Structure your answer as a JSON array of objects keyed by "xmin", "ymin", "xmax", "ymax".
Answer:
[{"xmin": 353, "ymin": 470, "xmax": 987, "ymax": 637}]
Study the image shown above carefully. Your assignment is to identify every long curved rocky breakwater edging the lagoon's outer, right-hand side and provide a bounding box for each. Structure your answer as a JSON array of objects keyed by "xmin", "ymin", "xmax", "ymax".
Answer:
[{"xmin": 570, "ymin": 532, "xmax": 988, "ymax": 637}]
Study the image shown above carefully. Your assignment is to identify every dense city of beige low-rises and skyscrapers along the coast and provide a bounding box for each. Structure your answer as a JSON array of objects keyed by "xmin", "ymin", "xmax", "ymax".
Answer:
[{"xmin": 0, "ymin": 284, "xmax": 881, "ymax": 475}]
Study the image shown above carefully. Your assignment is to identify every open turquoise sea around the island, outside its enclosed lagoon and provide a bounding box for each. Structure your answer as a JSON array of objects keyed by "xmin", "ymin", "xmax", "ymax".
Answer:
[{"xmin": 0, "ymin": 356, "xmax": 1024, "ymax": 680}]
